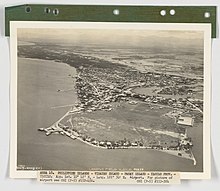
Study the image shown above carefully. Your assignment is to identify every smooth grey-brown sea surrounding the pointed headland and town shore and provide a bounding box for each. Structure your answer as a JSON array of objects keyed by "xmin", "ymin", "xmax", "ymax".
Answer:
[{"xmin": 17, "ymin": 58, "xmax": 202, "ymax": 172}]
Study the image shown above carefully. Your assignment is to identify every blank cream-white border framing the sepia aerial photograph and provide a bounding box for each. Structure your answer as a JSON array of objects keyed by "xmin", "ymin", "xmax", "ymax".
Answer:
[{"xmin": 10, "ymin": 21, "xmax": 211, "ymax": 179}]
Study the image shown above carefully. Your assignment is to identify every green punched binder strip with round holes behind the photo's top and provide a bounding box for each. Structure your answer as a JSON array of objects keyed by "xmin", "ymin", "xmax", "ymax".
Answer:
[{"xmin": 5, "ymin": 4, "xmax": 216, "ymax": 38}]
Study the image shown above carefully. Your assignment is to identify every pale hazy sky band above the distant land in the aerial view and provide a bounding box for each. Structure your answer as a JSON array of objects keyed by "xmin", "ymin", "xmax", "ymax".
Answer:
[{"xmin": 18, "ymin": 29, "xmax": 203, "ymax": 48}]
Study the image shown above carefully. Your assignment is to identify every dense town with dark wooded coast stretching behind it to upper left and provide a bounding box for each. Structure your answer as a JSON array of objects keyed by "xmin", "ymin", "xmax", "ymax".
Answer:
[{"xmin": 19, "ymin": 43, "xmax": 203, "ymax": 112}]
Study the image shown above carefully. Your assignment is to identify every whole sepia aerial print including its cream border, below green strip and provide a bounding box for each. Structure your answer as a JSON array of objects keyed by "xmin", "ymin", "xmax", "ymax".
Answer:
[{"xmin": 10, "ymin": 22, "xmax": 211, "ymax": 179}]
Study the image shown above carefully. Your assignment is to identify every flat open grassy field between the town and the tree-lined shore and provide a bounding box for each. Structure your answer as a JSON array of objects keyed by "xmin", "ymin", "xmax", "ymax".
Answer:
[{"xmin": 62, "ymin": 102, "xmax": 179, "ymax": 146}]
